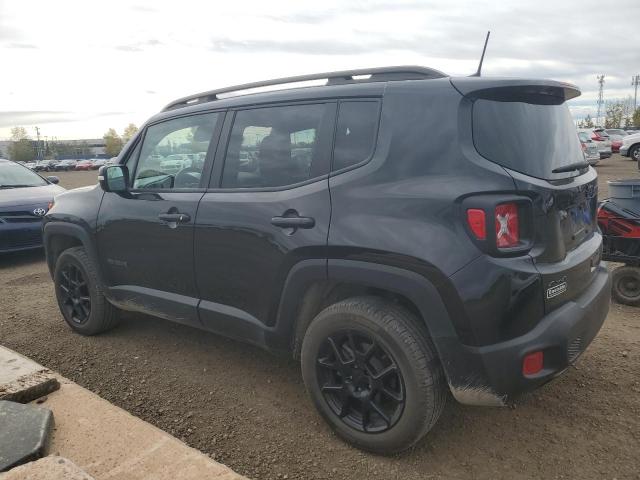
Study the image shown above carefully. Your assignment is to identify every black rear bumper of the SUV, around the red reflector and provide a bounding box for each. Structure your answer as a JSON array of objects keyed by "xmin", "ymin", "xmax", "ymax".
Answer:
[{"xmin": 448, "ymin": 264, "xmax": 611, "ymax": 405}]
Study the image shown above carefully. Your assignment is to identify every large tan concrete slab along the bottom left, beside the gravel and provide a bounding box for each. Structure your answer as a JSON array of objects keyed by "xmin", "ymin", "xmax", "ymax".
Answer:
[{"xmin": 37, "ymin": 378, "xmax": 244, "ymax": 480}]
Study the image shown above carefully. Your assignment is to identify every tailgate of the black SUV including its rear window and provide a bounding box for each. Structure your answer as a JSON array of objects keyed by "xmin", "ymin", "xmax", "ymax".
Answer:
[{"xmin": 472, "ymin": 89, "xmax": 602, "ymax": 311}]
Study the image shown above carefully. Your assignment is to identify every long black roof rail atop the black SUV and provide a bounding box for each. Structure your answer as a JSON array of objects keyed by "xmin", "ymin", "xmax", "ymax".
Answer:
[{"xmin": 162, "ymin": 66, "xmax": 447, "ymax": 112}]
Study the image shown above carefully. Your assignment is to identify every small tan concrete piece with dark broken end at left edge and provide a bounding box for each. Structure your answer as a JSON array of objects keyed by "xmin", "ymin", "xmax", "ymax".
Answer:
[{"xmin": 0, "ymin": 346, "xmax": 59, "ymax": 403}]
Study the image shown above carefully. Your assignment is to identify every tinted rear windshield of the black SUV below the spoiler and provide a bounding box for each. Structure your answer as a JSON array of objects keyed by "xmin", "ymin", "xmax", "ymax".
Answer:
[{"xmin": 473, "ymin": 99, "xmax": 584, "ymax": 180}]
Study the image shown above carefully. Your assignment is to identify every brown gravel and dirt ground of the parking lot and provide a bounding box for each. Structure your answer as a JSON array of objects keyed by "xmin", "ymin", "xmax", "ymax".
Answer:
[{"xmin": 0, "ymin": 155, "xmax": 640, "ymax": 480}]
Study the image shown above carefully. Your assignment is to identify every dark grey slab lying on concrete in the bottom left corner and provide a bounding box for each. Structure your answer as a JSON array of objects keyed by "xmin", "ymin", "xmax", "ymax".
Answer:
[{"xmin": 0, "ymin": 400, "xmax": 53, "ymax": 472}]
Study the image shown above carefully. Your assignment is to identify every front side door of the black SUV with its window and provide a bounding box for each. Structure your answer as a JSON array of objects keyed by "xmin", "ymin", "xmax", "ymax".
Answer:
[{"xmin": 97, "ymin": 113, "xmax": 223, "ymax": 325}]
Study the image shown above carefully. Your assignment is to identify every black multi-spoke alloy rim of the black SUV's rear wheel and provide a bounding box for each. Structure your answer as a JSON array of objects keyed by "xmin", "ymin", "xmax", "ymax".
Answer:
[{"xmin": 316, "ymin": 330, "xmax": 405, "ymax": 433}]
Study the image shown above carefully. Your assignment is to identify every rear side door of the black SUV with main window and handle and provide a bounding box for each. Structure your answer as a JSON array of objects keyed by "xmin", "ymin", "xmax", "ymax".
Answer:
[{"xmin": 195, "ymin": 101, "xmax": 336, "ymax": 341}]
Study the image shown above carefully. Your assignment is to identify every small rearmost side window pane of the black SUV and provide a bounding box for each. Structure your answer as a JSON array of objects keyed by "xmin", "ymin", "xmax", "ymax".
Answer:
[{"xmin": 332, "ymin": 100, "xmax": 379, "ymax": 171}]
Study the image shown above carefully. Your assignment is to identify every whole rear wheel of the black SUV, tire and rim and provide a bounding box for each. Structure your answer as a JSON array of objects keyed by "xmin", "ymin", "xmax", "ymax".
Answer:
[{"xmin": 301, "ymin": 297, "xmax": 447, "ymax": 455}]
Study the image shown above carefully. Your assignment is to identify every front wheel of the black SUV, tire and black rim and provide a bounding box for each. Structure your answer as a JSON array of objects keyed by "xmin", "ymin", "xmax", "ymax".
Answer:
[{"xmin": 53, "ymin": 247, "xmax": 120, "ymax": 335}]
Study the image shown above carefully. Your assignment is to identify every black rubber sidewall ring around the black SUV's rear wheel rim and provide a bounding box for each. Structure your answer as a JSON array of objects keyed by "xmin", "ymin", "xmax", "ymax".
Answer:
[{"xmin": 301, "ymin": 312, "xmax": 427, "ymax": 454}]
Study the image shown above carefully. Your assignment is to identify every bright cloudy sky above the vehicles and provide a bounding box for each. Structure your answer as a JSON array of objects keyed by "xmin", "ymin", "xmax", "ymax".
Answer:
[{"xmin": 0, "ymin": 0, "xmax": 640, "ymax": 139}]
